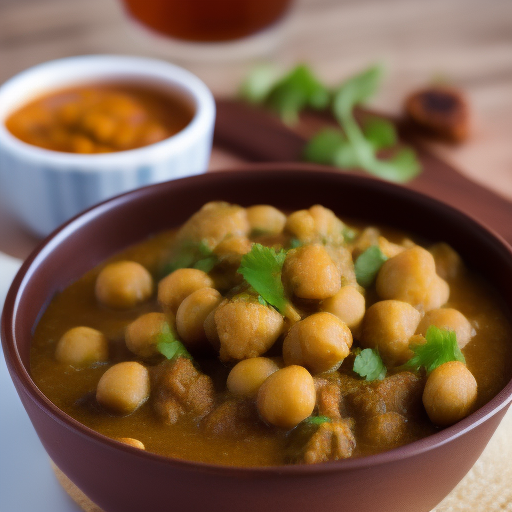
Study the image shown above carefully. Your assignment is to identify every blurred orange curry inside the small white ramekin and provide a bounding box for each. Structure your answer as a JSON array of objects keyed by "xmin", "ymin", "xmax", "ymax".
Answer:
[{"xmin": 5, "ymin": 83, "xmax": 194, "ymax": 154}]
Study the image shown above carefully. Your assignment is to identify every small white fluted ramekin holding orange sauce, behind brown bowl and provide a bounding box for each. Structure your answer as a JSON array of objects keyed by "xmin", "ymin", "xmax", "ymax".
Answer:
[{"xmin": 0, "ymin": 55, "xmax": 215, "ymax": 236}]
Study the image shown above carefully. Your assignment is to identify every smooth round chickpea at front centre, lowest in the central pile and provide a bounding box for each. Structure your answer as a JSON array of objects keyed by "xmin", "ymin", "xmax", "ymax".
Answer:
[{"xmin": 257, "ymin": 365, "xmax": 316, "ymax": 430}]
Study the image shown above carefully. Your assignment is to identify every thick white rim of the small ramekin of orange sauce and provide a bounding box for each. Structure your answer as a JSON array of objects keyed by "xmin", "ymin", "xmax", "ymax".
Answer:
[{"xmin": 0, "ymin": 54, "xmax": 216, "ymax": 169}]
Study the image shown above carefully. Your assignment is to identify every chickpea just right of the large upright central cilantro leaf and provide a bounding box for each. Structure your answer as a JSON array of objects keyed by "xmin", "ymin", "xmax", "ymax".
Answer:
[{"xmin": 283, "ymin": 244, "xmax": 341, "ymax": 300}]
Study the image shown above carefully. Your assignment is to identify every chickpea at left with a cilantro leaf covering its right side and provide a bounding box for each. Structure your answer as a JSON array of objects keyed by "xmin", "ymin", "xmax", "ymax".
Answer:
[{"xmin": 125, "ymin": 313, "xmax": 168, "ymax": 358}]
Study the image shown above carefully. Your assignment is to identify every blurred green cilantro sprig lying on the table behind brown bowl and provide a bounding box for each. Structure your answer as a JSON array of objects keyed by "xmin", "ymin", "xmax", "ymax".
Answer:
[{"xmin": 241, "ymin": 64, "xmax": 421, "ymax": 182}]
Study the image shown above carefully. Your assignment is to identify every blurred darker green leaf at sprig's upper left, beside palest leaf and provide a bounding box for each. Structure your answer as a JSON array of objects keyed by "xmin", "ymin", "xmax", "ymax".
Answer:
[{"xmin": 267, "ymin": 64, "xmax": 330, "ymax": 124}]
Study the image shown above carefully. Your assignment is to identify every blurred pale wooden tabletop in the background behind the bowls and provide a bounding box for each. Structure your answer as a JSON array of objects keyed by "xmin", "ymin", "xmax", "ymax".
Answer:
[{"xmin": 0, "ymin": 0, "xmax": 512, "ymax": 258}]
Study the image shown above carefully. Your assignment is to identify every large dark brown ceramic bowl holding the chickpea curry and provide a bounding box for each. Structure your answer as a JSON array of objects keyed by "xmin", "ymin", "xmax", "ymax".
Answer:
[{"xmin": 2, "ymin": 164, "xmax": 512, "ymax": 512}]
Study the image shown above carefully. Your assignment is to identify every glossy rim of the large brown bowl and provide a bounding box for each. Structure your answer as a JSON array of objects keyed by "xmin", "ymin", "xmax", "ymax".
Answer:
[{"xmin": 1, "ymin": 163, "xmax": 512, "ymax": 477}]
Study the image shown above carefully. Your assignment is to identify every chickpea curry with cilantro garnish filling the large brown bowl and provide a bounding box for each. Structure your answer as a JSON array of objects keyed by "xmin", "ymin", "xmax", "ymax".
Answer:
[{"xmin": 31, "ymin": 202, "xmax": 512, "ymax": 466}]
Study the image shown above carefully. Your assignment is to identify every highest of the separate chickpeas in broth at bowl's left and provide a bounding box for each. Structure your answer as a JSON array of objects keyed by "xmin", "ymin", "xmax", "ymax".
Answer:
[{"xmin": 95, "ymin": 261, "xmax": 153, "ymax": 309}]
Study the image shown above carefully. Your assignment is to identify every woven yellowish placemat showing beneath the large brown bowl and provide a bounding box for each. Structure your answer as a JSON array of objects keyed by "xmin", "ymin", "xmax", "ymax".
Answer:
[{"xmin": 52, "ymin": 408, "xmax": 512, "ymax": 512}]
